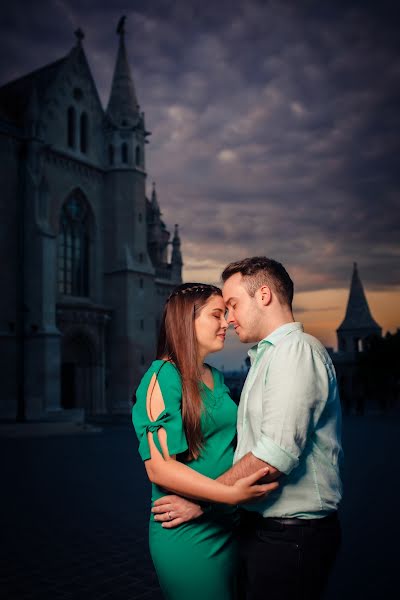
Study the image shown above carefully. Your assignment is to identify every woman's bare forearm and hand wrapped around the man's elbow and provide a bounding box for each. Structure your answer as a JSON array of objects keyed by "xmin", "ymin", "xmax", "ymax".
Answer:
[{"xmin": 145, "ymin": 428, "xmax": 278, "ymax": 505}]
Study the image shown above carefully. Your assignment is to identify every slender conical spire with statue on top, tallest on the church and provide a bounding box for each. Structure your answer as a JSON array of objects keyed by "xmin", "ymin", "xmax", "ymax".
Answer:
[{"xmin": 107, "ymin": 17, "xmax": 139, "ymax": 127}]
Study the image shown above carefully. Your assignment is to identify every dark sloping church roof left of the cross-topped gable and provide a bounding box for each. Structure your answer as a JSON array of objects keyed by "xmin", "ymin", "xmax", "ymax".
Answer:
[{"xmin": 0, "ymin": 57, "xmax": 67, "ymax": 125}]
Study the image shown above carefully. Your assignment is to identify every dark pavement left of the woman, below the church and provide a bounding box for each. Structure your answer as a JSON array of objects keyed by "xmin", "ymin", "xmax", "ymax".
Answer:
[{"xmin": 0, "ymin": 425, "xmax": 162, "ymax": 600}]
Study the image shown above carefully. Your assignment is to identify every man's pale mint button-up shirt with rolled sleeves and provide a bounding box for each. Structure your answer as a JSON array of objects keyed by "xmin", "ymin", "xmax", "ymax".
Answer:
[{"xmin": 234, "ymin": 323, "xmax": 342, "ymax": 519}]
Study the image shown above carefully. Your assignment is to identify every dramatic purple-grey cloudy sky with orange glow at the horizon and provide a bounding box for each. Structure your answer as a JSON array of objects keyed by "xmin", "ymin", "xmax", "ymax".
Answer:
[{"xmin": 0, "ymin": 0, "xmax": 400, "ymax": 366}]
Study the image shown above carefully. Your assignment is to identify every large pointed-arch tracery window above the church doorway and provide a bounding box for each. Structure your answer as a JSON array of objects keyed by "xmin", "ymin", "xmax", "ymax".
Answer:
[{"xmin": 58, "ymin": 195, "xmax": 90, "ymax": 296}]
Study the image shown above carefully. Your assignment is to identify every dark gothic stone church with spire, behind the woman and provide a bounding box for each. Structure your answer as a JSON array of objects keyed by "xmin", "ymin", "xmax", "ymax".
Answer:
[{"xmin": 0, "ymin": 23, "xmax": 182, "ymax": 419}]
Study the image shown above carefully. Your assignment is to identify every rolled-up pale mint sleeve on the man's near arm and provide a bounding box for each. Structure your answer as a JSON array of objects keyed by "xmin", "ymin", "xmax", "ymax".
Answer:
[{"xmin": 251, "ymin": 340, "xmax": 329, "ymax": 474}]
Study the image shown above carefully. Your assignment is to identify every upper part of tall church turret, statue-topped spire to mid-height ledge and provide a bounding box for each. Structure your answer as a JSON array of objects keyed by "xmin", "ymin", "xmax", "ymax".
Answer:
[{"xmin": 105, "ymin": 17, "xmax": 154, "ymax": 273}]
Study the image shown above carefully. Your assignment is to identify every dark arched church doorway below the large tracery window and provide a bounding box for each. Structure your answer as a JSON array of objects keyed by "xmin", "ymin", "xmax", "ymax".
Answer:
[{"xmin": 61, "ymin": 331, "xmax": 96, "ymax": 414}]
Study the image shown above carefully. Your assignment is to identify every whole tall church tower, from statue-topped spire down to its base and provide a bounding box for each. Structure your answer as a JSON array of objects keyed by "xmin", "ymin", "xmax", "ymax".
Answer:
[{"xmin": 104, "ymin": 17, "xmax": 156, "ymax": 412}]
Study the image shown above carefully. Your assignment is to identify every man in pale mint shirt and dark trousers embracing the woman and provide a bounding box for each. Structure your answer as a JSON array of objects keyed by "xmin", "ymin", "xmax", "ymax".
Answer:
[{"xmin": 153, "ymin": 257, "xmax": 342, "ymax": 600}]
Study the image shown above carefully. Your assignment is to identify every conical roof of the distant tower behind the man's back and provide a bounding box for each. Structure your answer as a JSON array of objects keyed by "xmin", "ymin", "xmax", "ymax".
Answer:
[{"xmin": 337, "ymin": 263, "xmax": 382, "ymax": 331}]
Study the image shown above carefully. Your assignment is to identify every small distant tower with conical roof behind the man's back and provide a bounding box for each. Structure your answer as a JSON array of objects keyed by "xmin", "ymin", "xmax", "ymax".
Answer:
[{"xmin": 336, "ymin": 263, "xmax": 382, "ymax": 353}]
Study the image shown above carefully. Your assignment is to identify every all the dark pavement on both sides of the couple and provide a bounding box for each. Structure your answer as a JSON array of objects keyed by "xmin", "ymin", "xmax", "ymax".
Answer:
[{"xmin": 0, "ymin": 417, "xmax": 400, "ymax": 600}]
